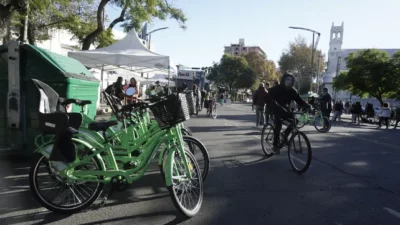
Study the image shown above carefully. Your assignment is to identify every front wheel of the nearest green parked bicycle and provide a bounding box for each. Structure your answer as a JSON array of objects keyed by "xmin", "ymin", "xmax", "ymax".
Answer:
[{"xmin": 166, "ymin": 151, "xmax": 203, "ymax": 217}]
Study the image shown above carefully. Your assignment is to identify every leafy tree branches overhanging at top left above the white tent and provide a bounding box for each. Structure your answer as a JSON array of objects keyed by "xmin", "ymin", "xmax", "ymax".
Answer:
[{"xmin": 0, "ymin": 0, "xmax": 187, "ymax": 48}]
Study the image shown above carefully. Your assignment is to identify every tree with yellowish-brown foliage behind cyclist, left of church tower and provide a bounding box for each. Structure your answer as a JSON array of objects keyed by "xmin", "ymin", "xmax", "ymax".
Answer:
[{"xmin": 278, "ymin": 36, "xmax": 325, "ymax": 94}]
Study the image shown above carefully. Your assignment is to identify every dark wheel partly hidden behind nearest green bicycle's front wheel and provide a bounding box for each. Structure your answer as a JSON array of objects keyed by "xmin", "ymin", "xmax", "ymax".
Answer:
[{"xmin": 183, "ymin": 136, "xmax": 210, "ymax": 182}]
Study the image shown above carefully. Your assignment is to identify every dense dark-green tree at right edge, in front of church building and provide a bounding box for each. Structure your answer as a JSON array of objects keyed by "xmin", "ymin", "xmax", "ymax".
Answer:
[{"xmin": 333, "ymin": 49, "xmax": 400, "ymax": 105}]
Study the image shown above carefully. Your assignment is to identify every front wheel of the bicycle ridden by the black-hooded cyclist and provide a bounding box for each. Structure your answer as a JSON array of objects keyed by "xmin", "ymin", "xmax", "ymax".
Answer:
[{"xmin": 288, "ymin": 131, "xmax": 312, "ymax": 174}]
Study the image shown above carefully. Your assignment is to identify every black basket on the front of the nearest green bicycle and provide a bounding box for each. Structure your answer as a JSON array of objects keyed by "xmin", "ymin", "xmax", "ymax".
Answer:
[{"xmin": 150, "ymin": 94, "xmax": 190, "ymax": 129}]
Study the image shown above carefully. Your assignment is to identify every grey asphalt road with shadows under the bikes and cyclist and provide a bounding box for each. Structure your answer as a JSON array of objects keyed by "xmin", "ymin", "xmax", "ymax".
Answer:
[{"xmin": 0, "ymin": 104, "xmax": 400, "ymax": 225}]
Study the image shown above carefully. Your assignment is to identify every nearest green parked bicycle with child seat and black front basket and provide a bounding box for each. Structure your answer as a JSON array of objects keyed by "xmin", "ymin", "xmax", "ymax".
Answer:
[{"xmin": 29, "ymin": 80, "xmax": 203, "ymax": 217}]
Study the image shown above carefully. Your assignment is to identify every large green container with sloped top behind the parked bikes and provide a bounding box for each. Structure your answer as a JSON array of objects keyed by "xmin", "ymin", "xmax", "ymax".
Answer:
[{"xmin": 0, "ymin": 41, "xmax": 99, "ymax": 155}]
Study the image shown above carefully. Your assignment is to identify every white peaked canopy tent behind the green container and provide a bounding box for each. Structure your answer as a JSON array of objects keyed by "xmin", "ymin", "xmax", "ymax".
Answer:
[{"xmin": 68, "ymin": 29, "xmax": 175, "ymax": 98}]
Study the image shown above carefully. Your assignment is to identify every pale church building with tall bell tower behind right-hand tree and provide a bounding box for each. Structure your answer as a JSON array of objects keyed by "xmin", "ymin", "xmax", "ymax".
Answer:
[{"xmin": 322, "ymin": 23, "xmax": 400, "ymax": 104}]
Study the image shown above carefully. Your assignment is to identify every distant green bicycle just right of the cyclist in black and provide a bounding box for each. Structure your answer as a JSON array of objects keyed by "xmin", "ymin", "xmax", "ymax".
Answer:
[{"xmin": 296, "ymin": 110, "xmax": 331, "ymax": 133}]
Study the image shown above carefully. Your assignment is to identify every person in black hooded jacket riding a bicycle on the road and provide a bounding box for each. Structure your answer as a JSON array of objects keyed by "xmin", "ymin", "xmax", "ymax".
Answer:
[{"xmin": 265, "ymin": 73, "xmax": 310, "ymax": 154}]
